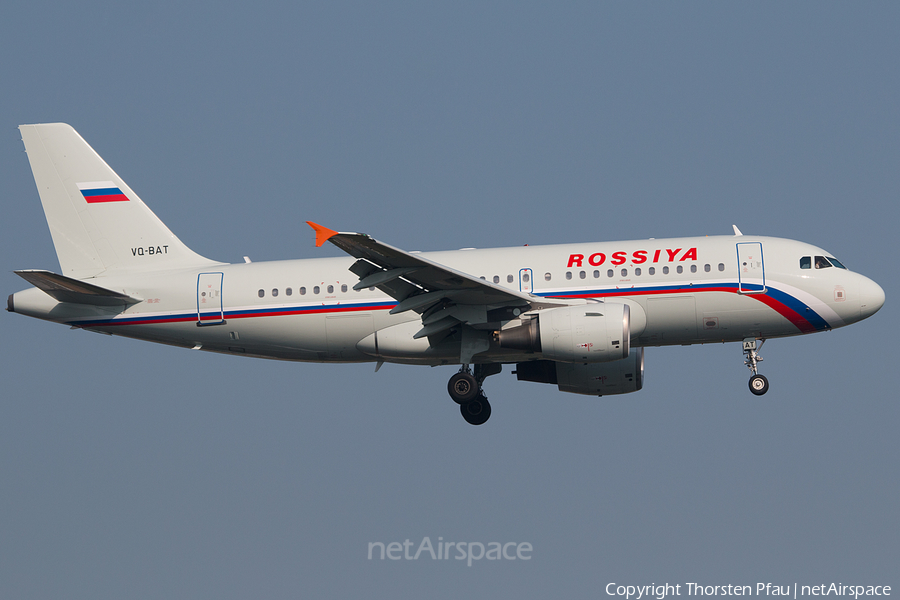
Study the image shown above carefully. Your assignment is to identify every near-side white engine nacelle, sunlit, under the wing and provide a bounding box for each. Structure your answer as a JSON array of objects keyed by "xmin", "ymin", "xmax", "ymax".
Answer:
[{"xmin": 496, "ymin": 302, "xmax": 631, "ymax": 363}]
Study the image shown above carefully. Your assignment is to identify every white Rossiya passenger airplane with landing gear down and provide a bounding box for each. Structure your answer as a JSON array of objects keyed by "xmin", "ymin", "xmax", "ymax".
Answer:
[{"xmin": 7, "ymin": 123, "xmax": 885, "ymax": 425}]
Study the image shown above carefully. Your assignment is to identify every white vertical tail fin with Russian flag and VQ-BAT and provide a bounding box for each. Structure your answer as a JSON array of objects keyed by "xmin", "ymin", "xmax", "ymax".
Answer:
[{"xmin": 19, "ymin": 123, "xmax": 217, "ymax": 279}]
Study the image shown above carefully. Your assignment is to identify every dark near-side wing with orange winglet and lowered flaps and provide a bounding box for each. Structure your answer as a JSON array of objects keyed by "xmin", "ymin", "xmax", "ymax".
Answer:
[{"xmin": 307, "ymin": 221, "xmax": 559, "ymax": 349}]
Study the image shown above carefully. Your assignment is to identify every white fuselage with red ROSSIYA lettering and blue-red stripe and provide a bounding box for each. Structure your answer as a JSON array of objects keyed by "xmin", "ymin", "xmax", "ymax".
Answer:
[{"xmin": 10, "ymin": 236, "xmax": 884, "ymax": 364}]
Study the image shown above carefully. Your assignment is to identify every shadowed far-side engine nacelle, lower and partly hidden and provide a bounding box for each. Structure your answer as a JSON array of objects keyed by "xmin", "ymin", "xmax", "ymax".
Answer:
[{"xmin": 516, "ymin": 348, "xmax": 644, "ymax": 396}]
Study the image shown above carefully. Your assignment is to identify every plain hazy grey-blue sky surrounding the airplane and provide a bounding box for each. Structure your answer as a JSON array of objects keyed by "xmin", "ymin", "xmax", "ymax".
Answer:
[{"xmin": 0, "ymin": 2, "xmax": 900, "ymax": 598}]
